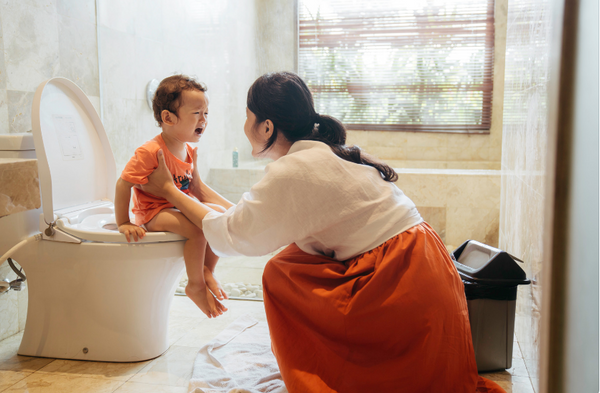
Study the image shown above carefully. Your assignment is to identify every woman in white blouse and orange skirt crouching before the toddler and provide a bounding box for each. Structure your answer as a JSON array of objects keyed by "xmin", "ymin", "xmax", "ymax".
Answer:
[{"xmin": 146, "ymin": 72, "xmax": 503, "ymax": 393}]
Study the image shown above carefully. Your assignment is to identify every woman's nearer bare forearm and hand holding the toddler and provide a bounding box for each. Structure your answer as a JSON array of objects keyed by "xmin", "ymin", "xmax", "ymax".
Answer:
[{"xmin": 136, "ymin": 150, "xmax": 216, "ymax": 229}]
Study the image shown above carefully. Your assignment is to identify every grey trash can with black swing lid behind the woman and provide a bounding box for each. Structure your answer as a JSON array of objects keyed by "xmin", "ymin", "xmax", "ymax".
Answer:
[{"xmin": 452, "ymin": 240, "xmax": 530, "ymax": 372}]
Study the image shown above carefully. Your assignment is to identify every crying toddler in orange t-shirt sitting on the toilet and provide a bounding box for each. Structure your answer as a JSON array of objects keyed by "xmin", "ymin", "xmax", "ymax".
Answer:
[{"xmin": 115, "ymin": 75, "xmax": 227, "ymax": 318}]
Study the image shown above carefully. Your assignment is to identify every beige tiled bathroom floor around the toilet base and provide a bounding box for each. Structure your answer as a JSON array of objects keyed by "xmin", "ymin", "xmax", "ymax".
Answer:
[{"xmin": 0, "ymin": 256, "xmax": 534, "ymax": 393}]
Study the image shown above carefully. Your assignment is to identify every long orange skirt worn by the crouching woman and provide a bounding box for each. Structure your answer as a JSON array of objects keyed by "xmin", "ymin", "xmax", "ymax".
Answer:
[{"xmin": 263, "ymin": 223, "xmax": 504, "ymax": 393}]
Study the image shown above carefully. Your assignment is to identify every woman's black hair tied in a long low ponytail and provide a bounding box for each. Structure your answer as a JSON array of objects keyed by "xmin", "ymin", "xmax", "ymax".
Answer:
[{"xmin": 247, "ymin": 72, "xmax": 398, "ymax": 182}]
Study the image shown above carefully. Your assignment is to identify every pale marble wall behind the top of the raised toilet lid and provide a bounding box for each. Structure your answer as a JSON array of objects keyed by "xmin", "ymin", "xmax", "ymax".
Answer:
[{"xmin": 0, "ymin": 0, "xmax": 100, "ymax": 134}]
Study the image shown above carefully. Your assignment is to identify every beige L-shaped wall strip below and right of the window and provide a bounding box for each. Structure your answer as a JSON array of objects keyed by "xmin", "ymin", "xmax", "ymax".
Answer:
[{"xmin": 348, "ymin": 0, "xmax": 509, "ymax": 169}]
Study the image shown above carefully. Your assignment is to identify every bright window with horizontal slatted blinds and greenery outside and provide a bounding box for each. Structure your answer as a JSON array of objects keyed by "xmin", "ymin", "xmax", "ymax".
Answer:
[{"xmin": 298, "ymin": 0, "xmax": 494, "ymax": 133}]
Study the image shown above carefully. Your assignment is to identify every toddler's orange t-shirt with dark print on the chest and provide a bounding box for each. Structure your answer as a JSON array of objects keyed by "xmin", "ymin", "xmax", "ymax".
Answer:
[{"xmin": 121, "ymin": 134, "xmax": 194, "ymax": 225}]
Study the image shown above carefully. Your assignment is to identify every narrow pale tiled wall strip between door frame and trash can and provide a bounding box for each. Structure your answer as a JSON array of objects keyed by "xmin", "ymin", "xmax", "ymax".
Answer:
[{"xmin": 500, "ymin": 0, "xmax": 551, "ymax": 386}]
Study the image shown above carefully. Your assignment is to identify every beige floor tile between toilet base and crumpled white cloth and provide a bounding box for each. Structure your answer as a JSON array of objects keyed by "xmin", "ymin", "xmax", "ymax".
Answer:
[{"xmin": 130, "ymin": 345, "xmax": 200, "ymax": 387}]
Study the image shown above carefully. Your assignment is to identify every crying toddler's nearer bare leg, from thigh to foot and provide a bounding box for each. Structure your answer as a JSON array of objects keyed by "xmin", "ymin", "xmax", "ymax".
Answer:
[{"xmin": 146, "ymin": 209, "xmax": 227, "ymax": 318}]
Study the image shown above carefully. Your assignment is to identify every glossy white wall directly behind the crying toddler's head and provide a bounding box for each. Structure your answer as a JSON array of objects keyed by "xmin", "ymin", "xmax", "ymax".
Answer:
[{"xmin": 99, "ymin": 0, "xmax": 258, "ymax": 176}]
